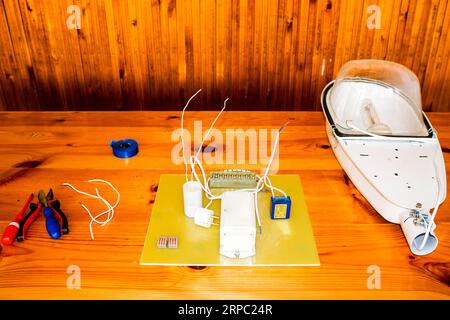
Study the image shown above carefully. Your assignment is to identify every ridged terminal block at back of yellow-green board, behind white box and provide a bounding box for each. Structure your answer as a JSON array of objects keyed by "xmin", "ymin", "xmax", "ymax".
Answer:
[{"xmin": 209, "ymin": 169, "xmax": 258, "ymax": 189}]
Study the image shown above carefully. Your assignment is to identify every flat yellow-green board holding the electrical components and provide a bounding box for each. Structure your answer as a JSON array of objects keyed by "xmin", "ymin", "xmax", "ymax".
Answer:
[{"xmin": 140, "ymin": 174, "xmax": 320, "ymax": 266}]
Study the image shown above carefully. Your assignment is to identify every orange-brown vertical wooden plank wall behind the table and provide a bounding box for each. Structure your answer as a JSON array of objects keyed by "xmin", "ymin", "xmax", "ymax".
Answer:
[{"xmin": 0, "ymin": 0, "xmax": 450, "ymax": 111}]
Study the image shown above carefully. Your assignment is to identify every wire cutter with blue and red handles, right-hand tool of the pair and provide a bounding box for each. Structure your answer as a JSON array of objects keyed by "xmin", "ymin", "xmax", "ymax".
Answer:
[{"xmin": 38, "ymin": 189, "xmax": 69, "ymax": 239}]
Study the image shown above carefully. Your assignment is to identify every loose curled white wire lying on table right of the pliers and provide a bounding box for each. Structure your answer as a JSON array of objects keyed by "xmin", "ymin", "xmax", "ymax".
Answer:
[{"xmin": 62, "ymin": 179, "xmax": 120, "ymax": 240}]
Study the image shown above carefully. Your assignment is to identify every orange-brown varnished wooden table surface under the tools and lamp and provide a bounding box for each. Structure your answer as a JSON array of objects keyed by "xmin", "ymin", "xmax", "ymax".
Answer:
[{"xmin": 0, "ymin": 112, "xmax": 450, "ymax": 299}]
